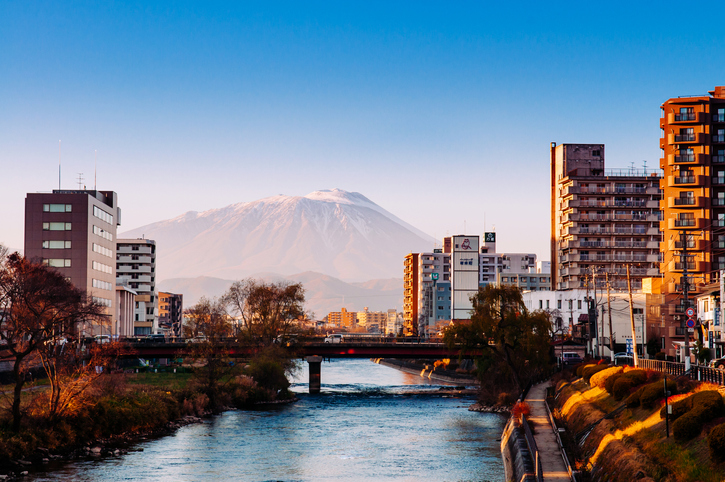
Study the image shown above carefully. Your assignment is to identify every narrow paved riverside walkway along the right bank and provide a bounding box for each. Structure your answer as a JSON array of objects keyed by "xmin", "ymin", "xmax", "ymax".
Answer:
[{"xmin": 526, "ymin": 382, "xmax": 571, "ymax": 482}]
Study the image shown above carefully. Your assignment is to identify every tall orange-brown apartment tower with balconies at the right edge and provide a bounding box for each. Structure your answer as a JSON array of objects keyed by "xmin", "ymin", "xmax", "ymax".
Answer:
[{"xmin": 660, "ymin": 86, "xmax": 725, "ymax": 354}]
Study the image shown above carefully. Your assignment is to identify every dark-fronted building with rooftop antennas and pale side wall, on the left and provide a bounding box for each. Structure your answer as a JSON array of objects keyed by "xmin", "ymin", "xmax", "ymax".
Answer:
[{"xmin": 25, "ymin": 189, "xmax": 121, "ymax": 335}]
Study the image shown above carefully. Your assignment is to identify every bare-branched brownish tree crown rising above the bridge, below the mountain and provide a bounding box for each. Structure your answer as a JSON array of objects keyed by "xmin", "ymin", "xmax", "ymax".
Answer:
[{"xmin": 223, "ymin": 278, "xmax": 305, "ymax": 345}]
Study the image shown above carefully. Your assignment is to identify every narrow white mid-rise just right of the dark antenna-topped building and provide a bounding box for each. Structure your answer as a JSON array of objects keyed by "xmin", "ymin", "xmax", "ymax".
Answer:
[{"xmin": 116, "ymin": 239, "xmax": 159, "ymax": 336}]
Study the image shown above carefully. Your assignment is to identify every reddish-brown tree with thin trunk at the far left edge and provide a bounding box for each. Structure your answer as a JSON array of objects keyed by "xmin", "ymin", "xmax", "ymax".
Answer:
[{"xmin": 0, "ymin": 253, "xmax": 104, "ymax": 432}]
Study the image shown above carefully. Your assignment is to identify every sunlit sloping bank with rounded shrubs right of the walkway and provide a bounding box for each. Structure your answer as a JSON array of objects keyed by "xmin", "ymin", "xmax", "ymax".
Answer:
[{"xmin": 555, "ymin": 368, "xmax": 725, "ymax": 482}]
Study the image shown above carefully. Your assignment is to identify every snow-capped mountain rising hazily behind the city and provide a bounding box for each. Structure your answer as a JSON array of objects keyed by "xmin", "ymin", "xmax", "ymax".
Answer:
[{"xmin": 119, "ymin": 189, "xmax": 434, "ymax": 281}]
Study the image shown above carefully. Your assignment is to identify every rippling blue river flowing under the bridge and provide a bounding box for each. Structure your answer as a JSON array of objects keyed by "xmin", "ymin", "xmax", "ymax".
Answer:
[{"xmin": 26, "ymin": 360, "xmax": 506, "ymax": 482}]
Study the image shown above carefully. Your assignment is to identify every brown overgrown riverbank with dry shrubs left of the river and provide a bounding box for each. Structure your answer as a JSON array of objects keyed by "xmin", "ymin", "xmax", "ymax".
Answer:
[{"xmin": 0, "ymin": 360, "xmax": 294, "ymax": 474}]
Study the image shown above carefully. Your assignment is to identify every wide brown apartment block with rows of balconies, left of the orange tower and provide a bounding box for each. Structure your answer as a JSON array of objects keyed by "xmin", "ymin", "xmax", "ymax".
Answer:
[{"xmin": 551, "ymin": 143, "xmax": 662, "ymax": 290}]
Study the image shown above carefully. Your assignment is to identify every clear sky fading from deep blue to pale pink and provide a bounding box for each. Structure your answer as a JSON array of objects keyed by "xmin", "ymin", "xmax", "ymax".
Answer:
[{"xmin": 0, "ymin": 0, "xmax": 725, "ymax": 260}]
